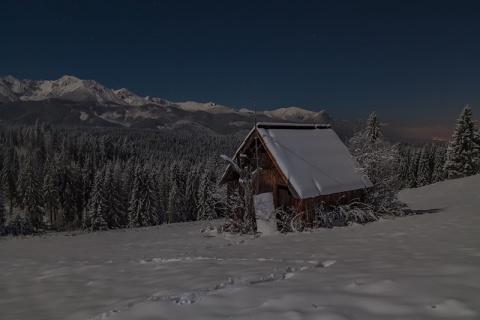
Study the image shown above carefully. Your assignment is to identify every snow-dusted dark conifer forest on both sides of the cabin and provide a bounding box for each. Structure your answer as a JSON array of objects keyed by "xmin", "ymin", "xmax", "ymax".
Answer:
[{"xmin": 0, "ymin": 106, "xmax": 480, "ymax": 235}]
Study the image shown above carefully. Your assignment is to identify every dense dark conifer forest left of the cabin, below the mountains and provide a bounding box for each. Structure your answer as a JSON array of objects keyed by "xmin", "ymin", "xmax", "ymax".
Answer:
[{"xmin": 0, "ymin": 122, "xmax": 243, "ymax": 234}]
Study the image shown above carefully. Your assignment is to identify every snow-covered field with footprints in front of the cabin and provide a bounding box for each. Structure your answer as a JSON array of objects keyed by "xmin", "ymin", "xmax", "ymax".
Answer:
[{"xmin": 0, "ymin": 175, "xmax": 480, "ymax": 320}]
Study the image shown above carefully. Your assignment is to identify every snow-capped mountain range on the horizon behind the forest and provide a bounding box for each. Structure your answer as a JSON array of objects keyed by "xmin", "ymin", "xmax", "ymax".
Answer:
[{"xmin": 0, "ymin": 75, "xmax": 358, "ymax": 134}]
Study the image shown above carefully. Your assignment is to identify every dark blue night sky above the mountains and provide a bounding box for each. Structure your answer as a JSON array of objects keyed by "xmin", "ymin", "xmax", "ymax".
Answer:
[{"xmin": 0, "ymin": 0, "xmax": 480, "ymax": 125}]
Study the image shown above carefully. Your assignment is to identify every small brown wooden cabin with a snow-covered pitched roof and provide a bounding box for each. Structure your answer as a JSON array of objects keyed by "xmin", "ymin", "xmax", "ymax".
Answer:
[{"xmin": 220, "ymin": 122, "xmax": 373, "ymax": 228}]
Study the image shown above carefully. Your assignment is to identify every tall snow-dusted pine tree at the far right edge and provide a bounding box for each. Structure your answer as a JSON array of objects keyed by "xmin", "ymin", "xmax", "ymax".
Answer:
[{"xmin": 445, "ymin": 105, "xmax": 480, "ymax": 179}]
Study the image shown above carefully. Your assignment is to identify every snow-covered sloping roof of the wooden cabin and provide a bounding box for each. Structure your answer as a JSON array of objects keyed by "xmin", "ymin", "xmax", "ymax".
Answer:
[{"xmin": 224, "ymin": 122, "xmax": 373, "ymax": 199}]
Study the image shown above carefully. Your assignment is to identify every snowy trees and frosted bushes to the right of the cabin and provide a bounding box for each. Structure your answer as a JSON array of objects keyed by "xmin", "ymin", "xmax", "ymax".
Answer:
[{"xmin": 344, "ymin": 106, "xmax": 480, "ymax": 225}]
